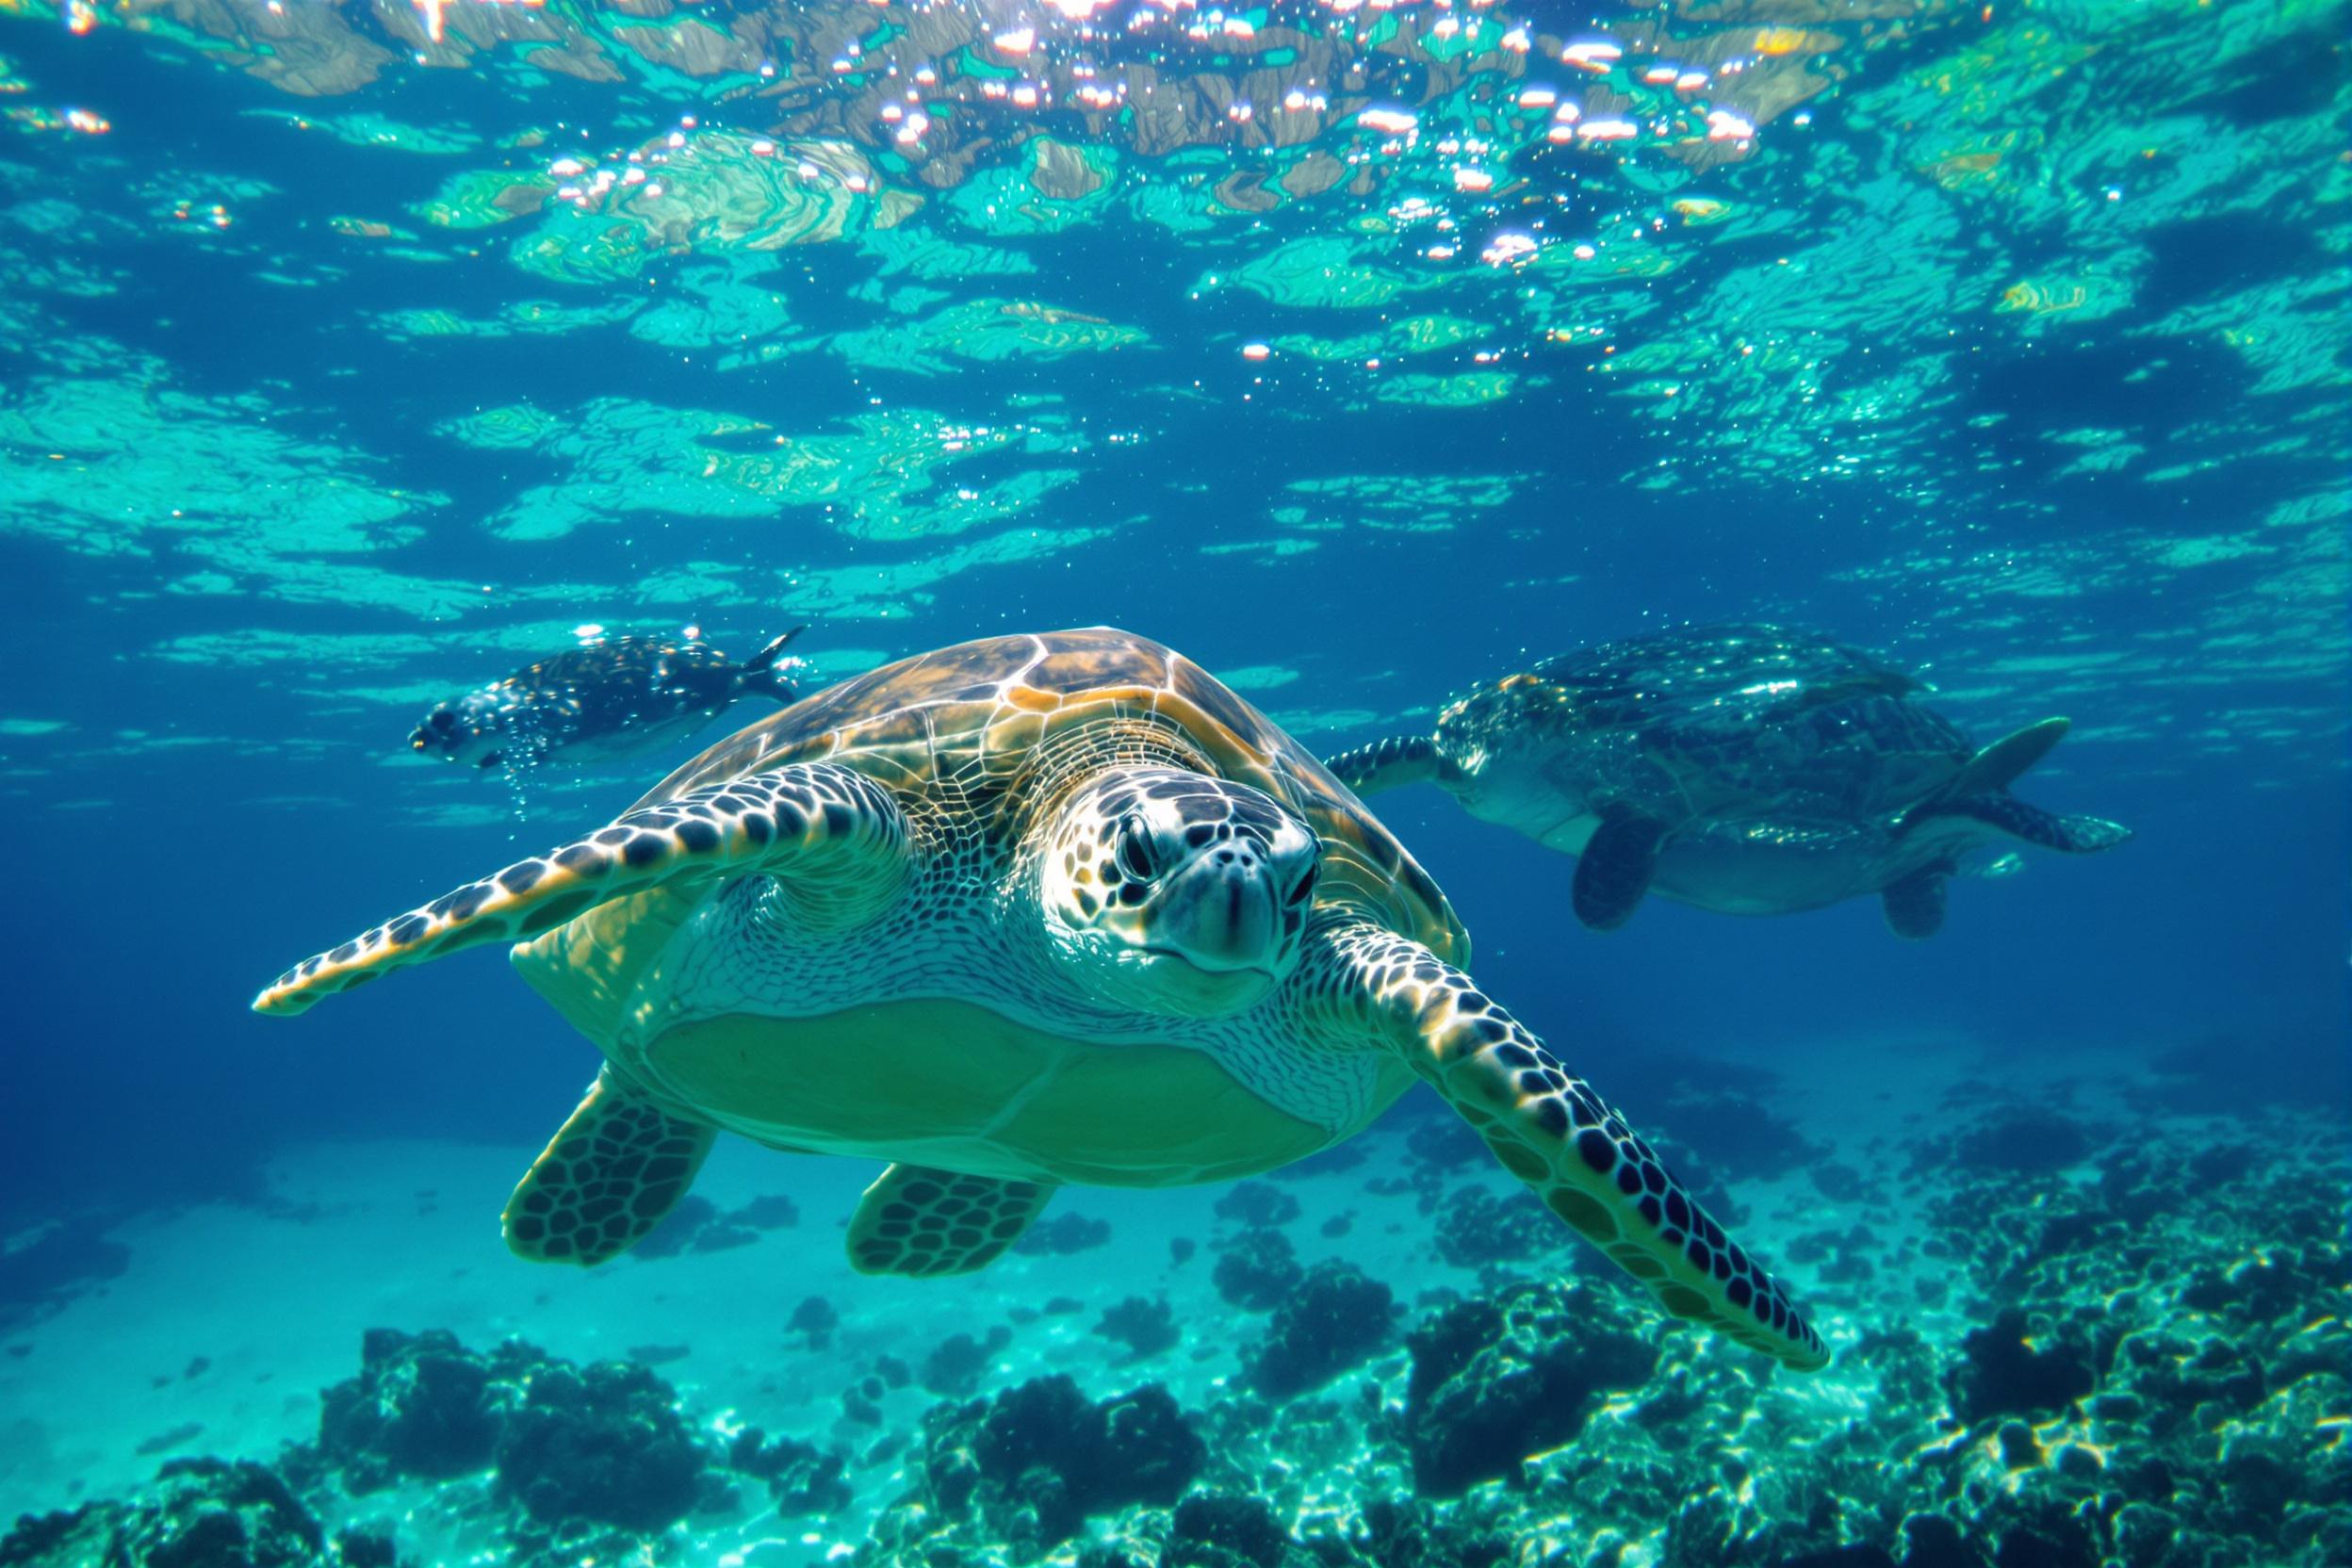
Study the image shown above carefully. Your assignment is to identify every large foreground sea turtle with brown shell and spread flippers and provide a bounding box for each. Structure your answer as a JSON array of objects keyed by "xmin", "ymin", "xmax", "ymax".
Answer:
[{"xmin": 254, "ymin": 628, "xmax": 1827, "ymax": 1368}]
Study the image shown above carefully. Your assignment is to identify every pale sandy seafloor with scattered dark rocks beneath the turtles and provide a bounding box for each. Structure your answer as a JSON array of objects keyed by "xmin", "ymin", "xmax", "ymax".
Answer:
[{"xmin": 0, "ymin": 1039, "xmax": 2352, "ymax": 1568}]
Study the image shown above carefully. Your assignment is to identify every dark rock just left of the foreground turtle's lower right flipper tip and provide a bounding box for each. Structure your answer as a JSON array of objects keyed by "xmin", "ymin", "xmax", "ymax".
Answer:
[{"xmin": 1404, "ymin": 1283, "xmax": 1658, "ymax": 1497}]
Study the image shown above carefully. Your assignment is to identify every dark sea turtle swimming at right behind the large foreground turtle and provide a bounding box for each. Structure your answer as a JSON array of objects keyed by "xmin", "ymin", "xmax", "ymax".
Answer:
[{"xmin": 1327, "ymin": 626, "xmax": 2131, "ymax": 938}]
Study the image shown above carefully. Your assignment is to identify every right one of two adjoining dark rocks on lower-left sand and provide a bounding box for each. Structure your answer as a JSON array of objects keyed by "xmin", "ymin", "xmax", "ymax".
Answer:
[{"xmin": 498, "ymin": 1361, "xmax": 706, "ymax": 1533}]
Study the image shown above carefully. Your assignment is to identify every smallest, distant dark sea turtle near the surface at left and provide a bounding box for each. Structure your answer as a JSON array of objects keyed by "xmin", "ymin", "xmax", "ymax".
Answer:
[{"xmin": 409, "ymin": 626, "xmax": 807, "ymax": 769}]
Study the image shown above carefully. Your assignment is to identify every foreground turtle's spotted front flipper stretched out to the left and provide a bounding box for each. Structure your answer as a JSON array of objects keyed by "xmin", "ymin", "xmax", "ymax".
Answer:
[{"xmin": 254, "ymin": 761, "xmax": 907, "ymax": 1013}]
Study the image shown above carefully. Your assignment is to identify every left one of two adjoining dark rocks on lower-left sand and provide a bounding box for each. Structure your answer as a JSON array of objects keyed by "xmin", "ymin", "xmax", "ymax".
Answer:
[{"xmin": 318, "ymin": 1329, "xmax": 510, "ymax": 1495}]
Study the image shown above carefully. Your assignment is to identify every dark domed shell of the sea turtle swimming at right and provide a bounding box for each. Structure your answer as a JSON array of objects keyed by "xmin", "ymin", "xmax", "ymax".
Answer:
[{"xmin": 1440, "ymin": 623, "xmax": 1973, "ymax": 823}]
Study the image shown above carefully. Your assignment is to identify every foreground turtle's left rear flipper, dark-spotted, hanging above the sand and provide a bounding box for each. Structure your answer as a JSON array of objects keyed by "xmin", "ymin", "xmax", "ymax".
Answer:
[{"xmin": 498, "ymin": 1068, "xmax": 717, "ymax": 1267}]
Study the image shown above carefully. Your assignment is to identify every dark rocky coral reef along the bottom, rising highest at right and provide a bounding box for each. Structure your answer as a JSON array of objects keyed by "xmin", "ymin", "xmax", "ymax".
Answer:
[{"xmin": 0, "ymin": 1101, "xmax": 2352, "ymax": 1568}]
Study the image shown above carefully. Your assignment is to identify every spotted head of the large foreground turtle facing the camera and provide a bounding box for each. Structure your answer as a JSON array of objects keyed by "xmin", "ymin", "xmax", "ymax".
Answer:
[{"xmin": 1037, "ymin": 766, "xmax": 1322, "ymax": 1018}]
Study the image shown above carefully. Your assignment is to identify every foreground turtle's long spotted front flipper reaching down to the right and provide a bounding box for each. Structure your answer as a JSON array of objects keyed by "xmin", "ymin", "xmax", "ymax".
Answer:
[{"xmin": 1300, "ymin": 922, "xmax": 1830, "ymax": 1370}]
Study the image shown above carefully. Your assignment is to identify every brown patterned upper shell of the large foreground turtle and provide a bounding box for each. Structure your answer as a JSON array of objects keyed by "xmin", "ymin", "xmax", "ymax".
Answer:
[{"xmin": 637, "ymin": 628, "xmax": 1470, "ymax": 964}]
